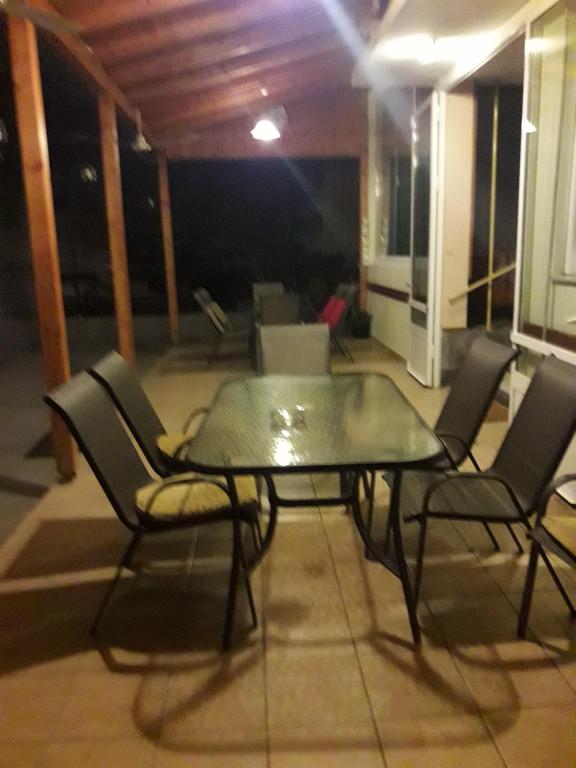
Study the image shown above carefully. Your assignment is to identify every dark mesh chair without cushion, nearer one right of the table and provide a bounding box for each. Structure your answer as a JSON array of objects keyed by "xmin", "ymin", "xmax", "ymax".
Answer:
[{"xmin": 401, "ymin": 357, "xmax": 576, "ymax": 608}]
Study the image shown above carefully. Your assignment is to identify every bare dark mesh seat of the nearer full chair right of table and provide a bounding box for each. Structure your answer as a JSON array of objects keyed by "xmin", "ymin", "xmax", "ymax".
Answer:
[{"xmin": 401, "ymin": 472, "xmax": 519, "ymax": 522}]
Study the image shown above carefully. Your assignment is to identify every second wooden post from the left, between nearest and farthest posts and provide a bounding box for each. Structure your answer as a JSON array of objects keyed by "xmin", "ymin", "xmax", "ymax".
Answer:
[{"xmin": 98, "ymin": 93, "xmax": 136, "ymax": 365}]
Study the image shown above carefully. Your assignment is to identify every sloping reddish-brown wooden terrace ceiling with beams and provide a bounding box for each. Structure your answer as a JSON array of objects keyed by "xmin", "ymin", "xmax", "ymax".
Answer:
[{"xmin": 53, "ymin": 0, "xmax": 375, "ymax": 154}]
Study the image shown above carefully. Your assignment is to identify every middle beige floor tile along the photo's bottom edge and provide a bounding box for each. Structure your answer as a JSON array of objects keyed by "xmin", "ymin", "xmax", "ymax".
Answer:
[{"xmin": 270, "ymin": 724, "xmax": 384, "ymax": 768}]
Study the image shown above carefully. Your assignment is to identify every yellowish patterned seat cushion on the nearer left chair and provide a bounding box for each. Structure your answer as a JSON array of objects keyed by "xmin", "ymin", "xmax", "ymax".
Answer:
[{"xmin": 136, "ymin": 472, "xmax": 258, "ymax": 518}]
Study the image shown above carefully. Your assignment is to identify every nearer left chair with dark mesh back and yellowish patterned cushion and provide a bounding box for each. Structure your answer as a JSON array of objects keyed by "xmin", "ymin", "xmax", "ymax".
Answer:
[{"xmin": 45, "ymin": 373, "xmax": 257, "ymax": 648}]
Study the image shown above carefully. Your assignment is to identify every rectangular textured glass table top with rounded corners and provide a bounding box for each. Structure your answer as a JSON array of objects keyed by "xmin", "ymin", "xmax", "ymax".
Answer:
[{"xmin": 186, "ymin": 374, "xmax": 443, "ymax": 473}]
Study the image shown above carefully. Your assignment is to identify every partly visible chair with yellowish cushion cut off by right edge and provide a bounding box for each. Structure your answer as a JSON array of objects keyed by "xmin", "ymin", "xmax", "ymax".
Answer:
[{"xmin": 518, "ymin": 475, "xmax": 576, "ymax": 638}]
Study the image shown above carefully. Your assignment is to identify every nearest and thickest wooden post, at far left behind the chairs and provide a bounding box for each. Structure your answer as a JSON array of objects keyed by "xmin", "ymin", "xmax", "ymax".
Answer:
[{"xmin": 7, "ymin": 15, "xmax": 75, "ymax": 479}]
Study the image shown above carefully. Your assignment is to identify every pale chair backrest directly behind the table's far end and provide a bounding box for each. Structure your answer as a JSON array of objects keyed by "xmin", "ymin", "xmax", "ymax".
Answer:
[{"xmin": 259, "ymin": 323, "xmax": 330, "ymax": 375}]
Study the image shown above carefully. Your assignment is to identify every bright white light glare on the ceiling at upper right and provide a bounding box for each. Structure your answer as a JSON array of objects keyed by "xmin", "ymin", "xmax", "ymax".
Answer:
[{"xmin": 376, "ymin": 35, "xmax": 490, "ymax": 65}]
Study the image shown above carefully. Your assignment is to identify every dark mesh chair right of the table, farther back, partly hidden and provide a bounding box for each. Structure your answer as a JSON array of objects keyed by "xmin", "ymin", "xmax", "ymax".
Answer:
[{"xmin": 369, "ymin": 336, "xmax": 522, "ymax": 551}]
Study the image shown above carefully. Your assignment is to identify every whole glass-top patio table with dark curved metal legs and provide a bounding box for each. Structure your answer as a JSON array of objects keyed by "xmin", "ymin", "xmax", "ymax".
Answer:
[{"xmin": 186, "ymin": 373, "xmax": 443, "ymax": 642}]
